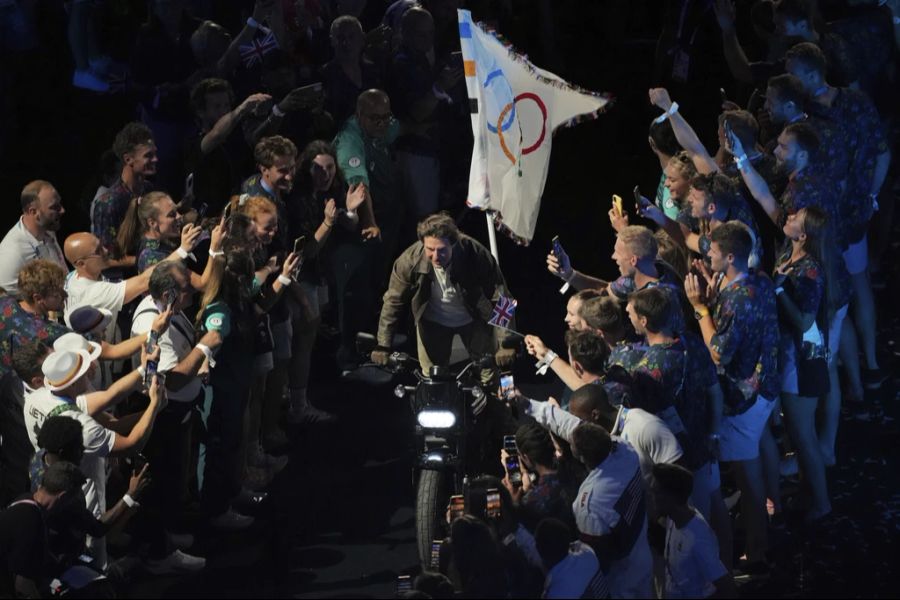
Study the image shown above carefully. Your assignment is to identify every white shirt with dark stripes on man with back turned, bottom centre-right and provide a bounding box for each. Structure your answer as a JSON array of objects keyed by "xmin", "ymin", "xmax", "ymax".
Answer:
[{"xmin": 572, "ymin": 442, "xmax": 653, "ymax": 598}]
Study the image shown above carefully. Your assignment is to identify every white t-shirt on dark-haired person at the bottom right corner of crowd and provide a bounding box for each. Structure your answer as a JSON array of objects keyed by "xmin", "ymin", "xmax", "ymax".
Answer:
[{"xmin": 665, "ymin": 510, "xmax": 728, "ymax": 598}]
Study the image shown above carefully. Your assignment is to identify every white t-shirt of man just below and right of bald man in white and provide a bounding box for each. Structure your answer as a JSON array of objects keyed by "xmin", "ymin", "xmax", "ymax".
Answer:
[{"xmin": 131, "ymin": 295, "xmax": 203, "ymax": 402}]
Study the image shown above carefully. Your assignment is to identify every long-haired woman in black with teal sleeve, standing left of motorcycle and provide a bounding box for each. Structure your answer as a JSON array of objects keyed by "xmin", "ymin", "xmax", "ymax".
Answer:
[{"xmin": 197, "ymin": 206, "xmax": 299, "ymax": 529}]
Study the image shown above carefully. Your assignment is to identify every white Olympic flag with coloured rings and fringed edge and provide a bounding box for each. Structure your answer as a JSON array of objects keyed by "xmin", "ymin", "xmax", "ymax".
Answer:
[{"xmin": 457, "ymin": 10, "xmax": 609, "ymax": 244}]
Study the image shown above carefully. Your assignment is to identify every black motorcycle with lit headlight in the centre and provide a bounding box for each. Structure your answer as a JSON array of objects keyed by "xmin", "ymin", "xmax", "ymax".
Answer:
[{"xmin": 357, "ymin": 333, "xmax": 493, "ymax": 568}]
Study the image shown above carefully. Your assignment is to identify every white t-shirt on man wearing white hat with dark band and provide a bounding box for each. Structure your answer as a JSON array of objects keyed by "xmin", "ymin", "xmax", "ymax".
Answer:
[{"xmin": 25, "ymin": 388, "xmax": 116, "ymax": 518}]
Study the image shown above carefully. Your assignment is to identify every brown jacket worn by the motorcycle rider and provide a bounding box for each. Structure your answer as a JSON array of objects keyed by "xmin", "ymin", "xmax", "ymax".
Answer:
[{"xmin": 378, "ymin": 234, "xmax": 515, "ymax": 348}]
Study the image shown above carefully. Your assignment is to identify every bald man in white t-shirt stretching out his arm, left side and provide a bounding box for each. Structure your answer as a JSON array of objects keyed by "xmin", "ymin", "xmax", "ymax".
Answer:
[{"xmin": 63, "ymin": 232, "xmax": 181, "ymax": 341}]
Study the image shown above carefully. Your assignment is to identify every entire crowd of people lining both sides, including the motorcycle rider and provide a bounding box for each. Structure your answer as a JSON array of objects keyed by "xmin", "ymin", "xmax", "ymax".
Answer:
[{"xmin": 0, "ymin": 0, "xmax": 897, "ymax": 598}]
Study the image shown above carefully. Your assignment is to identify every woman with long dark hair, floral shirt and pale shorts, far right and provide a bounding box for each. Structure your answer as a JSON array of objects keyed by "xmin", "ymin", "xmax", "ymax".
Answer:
[{"xmin": 774, "ymin": 206, "xmax": 831, "ymax": 521}]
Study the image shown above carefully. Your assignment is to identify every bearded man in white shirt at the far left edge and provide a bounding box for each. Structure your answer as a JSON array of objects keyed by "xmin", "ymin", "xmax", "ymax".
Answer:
[{"xmin": 0, "ymin": 179, "xmax": 66, "ymax": 295}]
